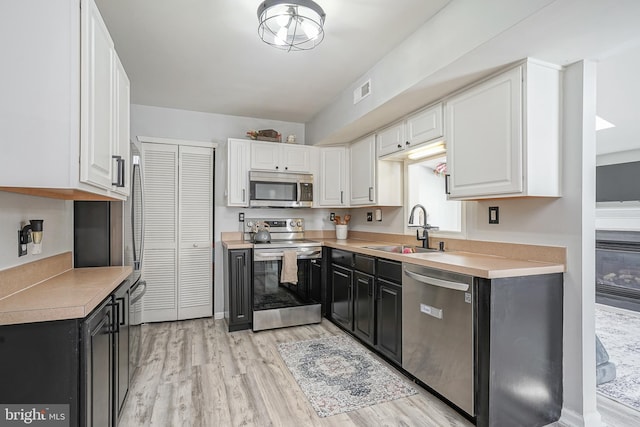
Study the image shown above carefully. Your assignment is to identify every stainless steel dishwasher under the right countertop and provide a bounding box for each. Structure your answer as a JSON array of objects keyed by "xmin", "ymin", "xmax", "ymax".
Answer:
[{"xmin": 402, "ymin": 263, "xmax": 475, "ymax": 416}]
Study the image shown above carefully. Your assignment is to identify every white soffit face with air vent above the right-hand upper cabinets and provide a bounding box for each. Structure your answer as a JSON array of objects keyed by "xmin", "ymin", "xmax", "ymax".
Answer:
[{"xmin": 306, "ymin": 0, "xmax": 552, "ymax": 145}]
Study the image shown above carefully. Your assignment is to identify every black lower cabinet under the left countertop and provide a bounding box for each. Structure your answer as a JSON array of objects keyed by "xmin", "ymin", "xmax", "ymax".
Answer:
[{"xmin": 0, "ymin": 281, "xmax": 130, "ymax": 427}]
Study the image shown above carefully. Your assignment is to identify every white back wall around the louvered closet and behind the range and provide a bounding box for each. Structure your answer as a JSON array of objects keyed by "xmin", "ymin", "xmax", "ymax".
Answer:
[{"xmin": 131, "ymin": 105, "xmax": 330, "ymax": 317}]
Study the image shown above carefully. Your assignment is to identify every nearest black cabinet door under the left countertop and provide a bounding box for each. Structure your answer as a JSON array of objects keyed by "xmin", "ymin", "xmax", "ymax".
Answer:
[{"xmin": 83, "ymin": 298, "xmax": 115, "ymax": 426}]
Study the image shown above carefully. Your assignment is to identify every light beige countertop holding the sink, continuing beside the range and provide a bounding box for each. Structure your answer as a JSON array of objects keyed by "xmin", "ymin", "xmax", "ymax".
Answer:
[{"xmin": 222, "ymin": 237, "xmax": 565, "ymax": 279}]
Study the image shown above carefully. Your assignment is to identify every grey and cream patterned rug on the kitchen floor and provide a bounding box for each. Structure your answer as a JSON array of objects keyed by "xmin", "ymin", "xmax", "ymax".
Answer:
[{"xmin": 278, "ymin": 336, "xmax": 417, "ymax": 417}]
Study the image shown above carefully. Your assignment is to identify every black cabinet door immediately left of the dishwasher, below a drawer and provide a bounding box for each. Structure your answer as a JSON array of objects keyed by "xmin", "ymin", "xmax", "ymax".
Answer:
[{"xmin": 376, "ymin": 279, "xmax": 402, "ymax": 363}]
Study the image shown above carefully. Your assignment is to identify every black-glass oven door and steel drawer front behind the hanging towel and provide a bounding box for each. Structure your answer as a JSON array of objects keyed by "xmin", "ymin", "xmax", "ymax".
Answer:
[{"xmin": 253, "ymin": 248, "xmax": 322, "ymax": 331}]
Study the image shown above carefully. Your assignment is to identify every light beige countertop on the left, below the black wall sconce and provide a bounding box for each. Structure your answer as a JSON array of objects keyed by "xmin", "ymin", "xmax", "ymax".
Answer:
[{"xmin": 0, "ymin": 266, "xmax": 132, "ymax": 325}]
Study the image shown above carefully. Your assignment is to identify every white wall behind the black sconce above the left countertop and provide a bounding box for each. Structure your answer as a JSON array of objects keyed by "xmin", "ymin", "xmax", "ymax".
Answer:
[{"xmin": 0, "ymin": 191, "xmax": 73, "ymax": 270}]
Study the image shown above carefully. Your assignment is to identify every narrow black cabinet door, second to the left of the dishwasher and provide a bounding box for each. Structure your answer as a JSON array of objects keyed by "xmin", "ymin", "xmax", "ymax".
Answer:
[{"xmin": 353, "ymin": 271, "xmax": 375, "ymax": 344}]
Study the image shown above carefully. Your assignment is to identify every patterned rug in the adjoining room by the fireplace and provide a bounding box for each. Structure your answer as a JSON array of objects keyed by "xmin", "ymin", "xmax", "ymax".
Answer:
[{"xmin": 596, "ymin": 308, "xmax": 640, "ymax": 411}]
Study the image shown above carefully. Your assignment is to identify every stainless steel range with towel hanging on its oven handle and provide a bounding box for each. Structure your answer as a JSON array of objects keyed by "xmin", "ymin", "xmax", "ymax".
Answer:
[{"xmin": 244, "ymin": 218, "xmax": 322, "ymax": 331}]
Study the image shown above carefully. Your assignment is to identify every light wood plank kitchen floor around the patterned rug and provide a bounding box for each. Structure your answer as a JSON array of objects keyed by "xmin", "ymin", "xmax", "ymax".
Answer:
[{"xmin": 119, "ymin": 319, "xmax": 473, "ymax": 427}]
